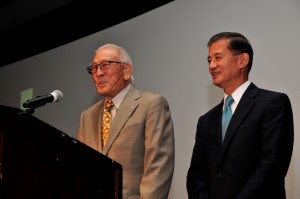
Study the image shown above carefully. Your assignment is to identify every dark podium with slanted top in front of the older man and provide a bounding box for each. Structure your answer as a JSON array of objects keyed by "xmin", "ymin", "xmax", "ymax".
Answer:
[{"xmin": 0, "ymin": 105, "xmax": 122, "ymax": 199}]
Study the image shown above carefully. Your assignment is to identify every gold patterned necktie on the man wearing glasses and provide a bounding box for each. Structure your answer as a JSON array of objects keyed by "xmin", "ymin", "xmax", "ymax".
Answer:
[{"xmin": 101, "ymin": 100, "xmax": 114, "ymax": 146}]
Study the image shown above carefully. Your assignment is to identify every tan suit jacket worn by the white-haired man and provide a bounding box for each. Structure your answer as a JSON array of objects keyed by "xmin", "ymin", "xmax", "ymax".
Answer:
[{"xmin": 78, "ymin": 86, "xmax": 175, "ymax": 199}]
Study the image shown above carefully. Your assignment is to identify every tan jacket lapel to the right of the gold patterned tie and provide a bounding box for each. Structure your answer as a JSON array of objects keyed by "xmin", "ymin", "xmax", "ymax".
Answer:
[{"xmin": 103, "ymin": 86, "xmax": 140, "ymax": 154}]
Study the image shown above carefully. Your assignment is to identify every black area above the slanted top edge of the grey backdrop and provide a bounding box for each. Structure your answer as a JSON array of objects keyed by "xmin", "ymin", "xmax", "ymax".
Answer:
[{"xmin": 0, "ymin": 0, "xmax": 172, "ymax": 67}]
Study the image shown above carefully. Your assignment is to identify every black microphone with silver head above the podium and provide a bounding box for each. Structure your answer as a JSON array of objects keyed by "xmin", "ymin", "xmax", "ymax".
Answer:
[{"xmin": 23, "ymin": 90, "xmax": 63, "ymax": 108}]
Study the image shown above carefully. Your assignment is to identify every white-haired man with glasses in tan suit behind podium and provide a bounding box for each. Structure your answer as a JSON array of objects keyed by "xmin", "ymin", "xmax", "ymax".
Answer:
[{"xmin": 78, "ymin": 44, "xmax": 175, "ymax": 199}]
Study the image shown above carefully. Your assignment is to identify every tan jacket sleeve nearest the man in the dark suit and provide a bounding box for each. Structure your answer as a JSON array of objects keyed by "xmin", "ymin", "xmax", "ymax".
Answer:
[{"xmin": 140, "ymin": 96, "xmax": 175, "ymax": 199}]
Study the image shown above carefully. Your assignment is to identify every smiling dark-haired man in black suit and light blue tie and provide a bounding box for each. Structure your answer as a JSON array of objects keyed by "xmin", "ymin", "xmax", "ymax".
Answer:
[{"xmin": 187, "ymin": 32, "xmax": 294, "ymax": 199}]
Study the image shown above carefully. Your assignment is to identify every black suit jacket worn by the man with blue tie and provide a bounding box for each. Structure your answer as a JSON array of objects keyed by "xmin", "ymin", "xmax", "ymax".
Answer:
[{"xmin": 187, "ymin": 83, "xmax": 294, "ymax": 199}]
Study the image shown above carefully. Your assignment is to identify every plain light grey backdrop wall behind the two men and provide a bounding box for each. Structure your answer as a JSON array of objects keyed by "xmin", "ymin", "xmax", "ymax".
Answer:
[{"xmin": 0, "ymin": 0, "xmax": 300, "ymax": 199}]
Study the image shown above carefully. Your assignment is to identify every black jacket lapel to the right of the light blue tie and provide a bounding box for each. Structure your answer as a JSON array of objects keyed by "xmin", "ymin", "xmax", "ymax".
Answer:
[{"xmin": 219, "ymin": 83, "xmax": 259, "ymax": 166}]
